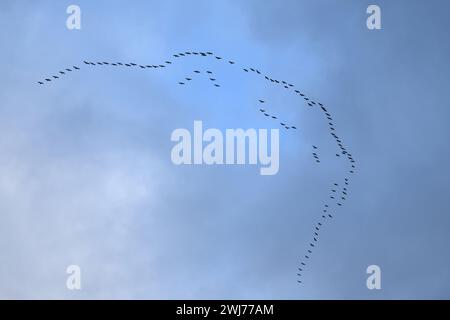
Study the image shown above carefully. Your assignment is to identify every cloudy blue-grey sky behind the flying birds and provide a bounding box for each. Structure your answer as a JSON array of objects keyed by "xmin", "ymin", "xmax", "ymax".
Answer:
[{"xmin": 0, "ymin": 0, "xmax": 450, "ymax": 299}]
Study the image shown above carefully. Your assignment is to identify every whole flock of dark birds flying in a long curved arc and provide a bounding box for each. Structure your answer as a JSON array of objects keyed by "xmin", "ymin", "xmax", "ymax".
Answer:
[{"xmin": 38, "ymin": 51, "xmax": 356, "ymax": 284}]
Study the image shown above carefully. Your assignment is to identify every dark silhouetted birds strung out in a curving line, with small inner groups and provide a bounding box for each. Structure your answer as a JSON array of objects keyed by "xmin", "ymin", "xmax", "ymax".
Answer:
[{"xmin": 38, "ymin": 51, "xmax": 356, "ymax": 283}]
